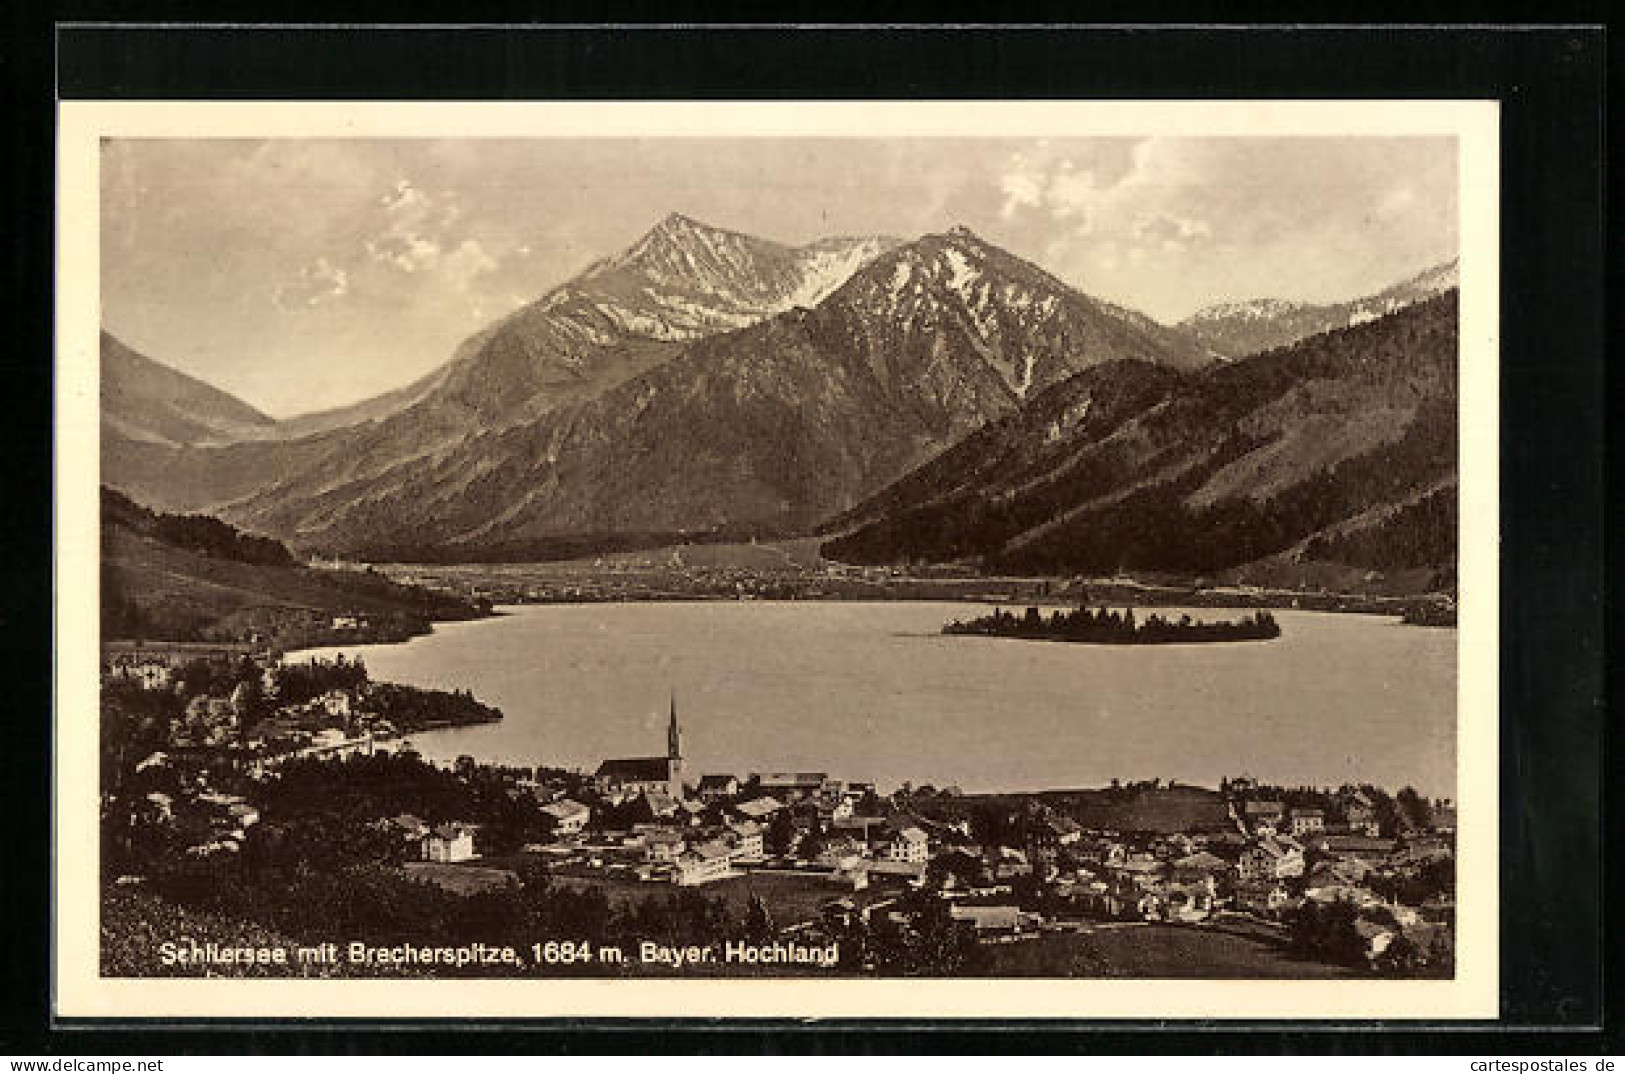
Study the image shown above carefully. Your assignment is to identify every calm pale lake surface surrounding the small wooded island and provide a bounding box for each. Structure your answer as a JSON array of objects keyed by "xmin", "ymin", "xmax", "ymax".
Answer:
[{"xmin": 295, "ymin": 601, "xmax": 1456, "ymax": 798}]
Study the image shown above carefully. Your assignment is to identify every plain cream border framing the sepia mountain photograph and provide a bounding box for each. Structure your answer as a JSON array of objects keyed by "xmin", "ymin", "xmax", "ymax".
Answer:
[{"xmin": 52, "ymin": 101, "xmax": 1500, "ymax": 1019}]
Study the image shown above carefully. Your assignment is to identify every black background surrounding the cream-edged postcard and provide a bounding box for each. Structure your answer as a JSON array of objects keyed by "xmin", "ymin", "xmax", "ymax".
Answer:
[{"xmin": 0, "ymin": 14, "xmax": 1619, "ymax": 1055}]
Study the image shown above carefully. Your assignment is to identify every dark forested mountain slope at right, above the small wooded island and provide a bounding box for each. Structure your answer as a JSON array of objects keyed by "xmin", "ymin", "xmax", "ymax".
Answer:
[{"xmin": 824, "ymin": 292, "xmax": 1458, "ymax": 588}]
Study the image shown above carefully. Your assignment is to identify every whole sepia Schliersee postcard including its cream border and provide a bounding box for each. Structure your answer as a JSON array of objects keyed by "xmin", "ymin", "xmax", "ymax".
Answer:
[{"xmin": 57, "ymin": 102, "xmax": 1498, "ymax": 1017}]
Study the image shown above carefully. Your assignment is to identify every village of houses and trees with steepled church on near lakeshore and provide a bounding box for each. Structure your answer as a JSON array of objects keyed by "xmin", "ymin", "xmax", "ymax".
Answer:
[{"xmin": 102, "ymin": 645, "xmax": 1454, "ymax": 975}]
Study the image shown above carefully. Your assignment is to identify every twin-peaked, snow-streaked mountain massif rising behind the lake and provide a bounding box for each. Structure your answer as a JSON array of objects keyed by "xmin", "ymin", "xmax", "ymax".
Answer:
[{"xmin": 104, "ymin": 216, "xmax": 1211, "ymax": 557}]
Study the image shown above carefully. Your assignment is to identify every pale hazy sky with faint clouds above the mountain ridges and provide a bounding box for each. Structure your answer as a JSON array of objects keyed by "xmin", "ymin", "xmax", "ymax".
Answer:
[{"xmin": 101, "ymin": 136, "xmax": 1458, "ymax": 418}]
